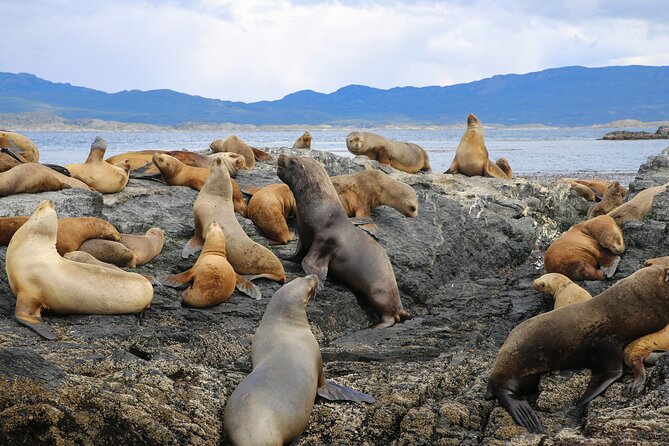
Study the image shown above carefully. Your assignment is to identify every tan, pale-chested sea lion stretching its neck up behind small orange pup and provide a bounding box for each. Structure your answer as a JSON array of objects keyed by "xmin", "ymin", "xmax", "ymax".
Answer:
[{"xmin": 181, "ymin": 158, "xmax": 286, "ymax": 282}]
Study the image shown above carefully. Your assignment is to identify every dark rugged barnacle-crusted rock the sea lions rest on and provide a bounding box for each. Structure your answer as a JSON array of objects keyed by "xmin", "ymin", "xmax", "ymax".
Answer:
[{"xmin": 0, "ymin": 149, "xmax": 669, "ymax": 445}]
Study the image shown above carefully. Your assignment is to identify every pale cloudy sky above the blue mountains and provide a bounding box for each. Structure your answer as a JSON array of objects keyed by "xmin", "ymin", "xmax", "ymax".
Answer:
[{"xmin": 0, "ymin": 0, "xmax": 669, "ymax": 102}]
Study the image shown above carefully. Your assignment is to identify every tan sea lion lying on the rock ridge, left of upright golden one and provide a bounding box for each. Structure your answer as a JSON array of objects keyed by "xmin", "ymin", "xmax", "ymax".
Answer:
[{"xmin": 346, "ymin": 131, "xmax": 432, "ymax": 173}]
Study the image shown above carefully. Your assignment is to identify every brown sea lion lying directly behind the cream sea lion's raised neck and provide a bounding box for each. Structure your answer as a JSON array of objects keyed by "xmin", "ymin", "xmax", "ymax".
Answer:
[{"xmin": 0, "ymin": 216, "xmax": 121, "ymax": 255}]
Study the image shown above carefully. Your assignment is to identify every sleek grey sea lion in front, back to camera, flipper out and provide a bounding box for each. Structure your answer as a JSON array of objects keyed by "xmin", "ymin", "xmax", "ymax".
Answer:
[{"xmin": 223, "ymin": 275, "xmax": 375, "ymax": 446}]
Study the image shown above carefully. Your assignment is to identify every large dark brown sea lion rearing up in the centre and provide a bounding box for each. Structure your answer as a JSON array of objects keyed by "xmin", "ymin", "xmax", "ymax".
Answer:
[{"xmin": 277, "ymin": 155, "xmax": 411, "ymax": 328}]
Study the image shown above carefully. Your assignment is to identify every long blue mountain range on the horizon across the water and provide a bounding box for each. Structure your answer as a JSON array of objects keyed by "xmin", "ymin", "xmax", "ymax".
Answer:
[{"xmin": 0, "ymin": 65, "xmax": 669, "ymax": 126}]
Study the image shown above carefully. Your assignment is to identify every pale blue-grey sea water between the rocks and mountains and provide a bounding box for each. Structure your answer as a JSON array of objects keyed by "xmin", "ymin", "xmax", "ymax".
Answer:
[{"xmin": 22, "ymin": 128, "xmax": 669, "ymax": 177}]
